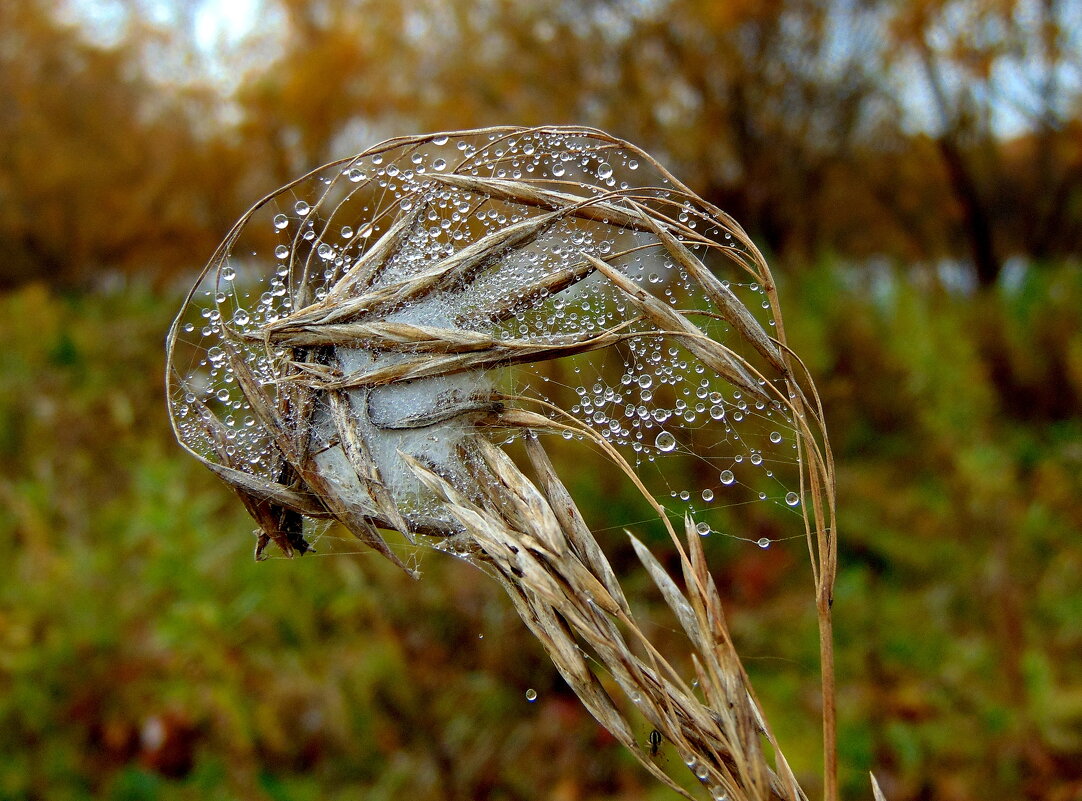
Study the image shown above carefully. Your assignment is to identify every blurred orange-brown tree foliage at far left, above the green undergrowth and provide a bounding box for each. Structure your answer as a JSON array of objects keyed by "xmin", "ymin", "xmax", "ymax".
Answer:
[{"xmin": 0, "ymin": 0, "xmax": 245, "ymax": 287}]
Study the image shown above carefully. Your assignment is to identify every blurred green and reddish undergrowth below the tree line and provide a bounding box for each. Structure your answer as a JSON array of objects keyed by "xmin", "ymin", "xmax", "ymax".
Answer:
[{"xmin": 0, "ymin": 265, "xmax": 1082, "ymax": 801}]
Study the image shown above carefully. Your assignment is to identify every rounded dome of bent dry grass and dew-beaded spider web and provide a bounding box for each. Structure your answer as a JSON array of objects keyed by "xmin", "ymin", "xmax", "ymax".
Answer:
[{"xmin": 168, "ymin": 128, "xmax": 832, "ymax": 800}]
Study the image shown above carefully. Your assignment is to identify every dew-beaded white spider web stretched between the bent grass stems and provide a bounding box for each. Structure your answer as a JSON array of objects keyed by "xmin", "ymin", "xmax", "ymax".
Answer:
[{"xmin": 170, "ymin": 129, "xmax": 801, "ymax": 547}]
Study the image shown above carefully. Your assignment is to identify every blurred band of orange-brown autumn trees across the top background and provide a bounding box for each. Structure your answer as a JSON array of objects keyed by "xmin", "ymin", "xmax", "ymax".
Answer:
[{"xmin": 0, "ymin": 0, "xmax": 1082, "ymax": 286}]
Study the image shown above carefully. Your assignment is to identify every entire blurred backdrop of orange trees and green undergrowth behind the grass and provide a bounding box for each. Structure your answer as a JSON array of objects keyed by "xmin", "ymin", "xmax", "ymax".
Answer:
[{"xmin": 0, "ymin": 0, "xmax": 1082, "ymax": 801}]
